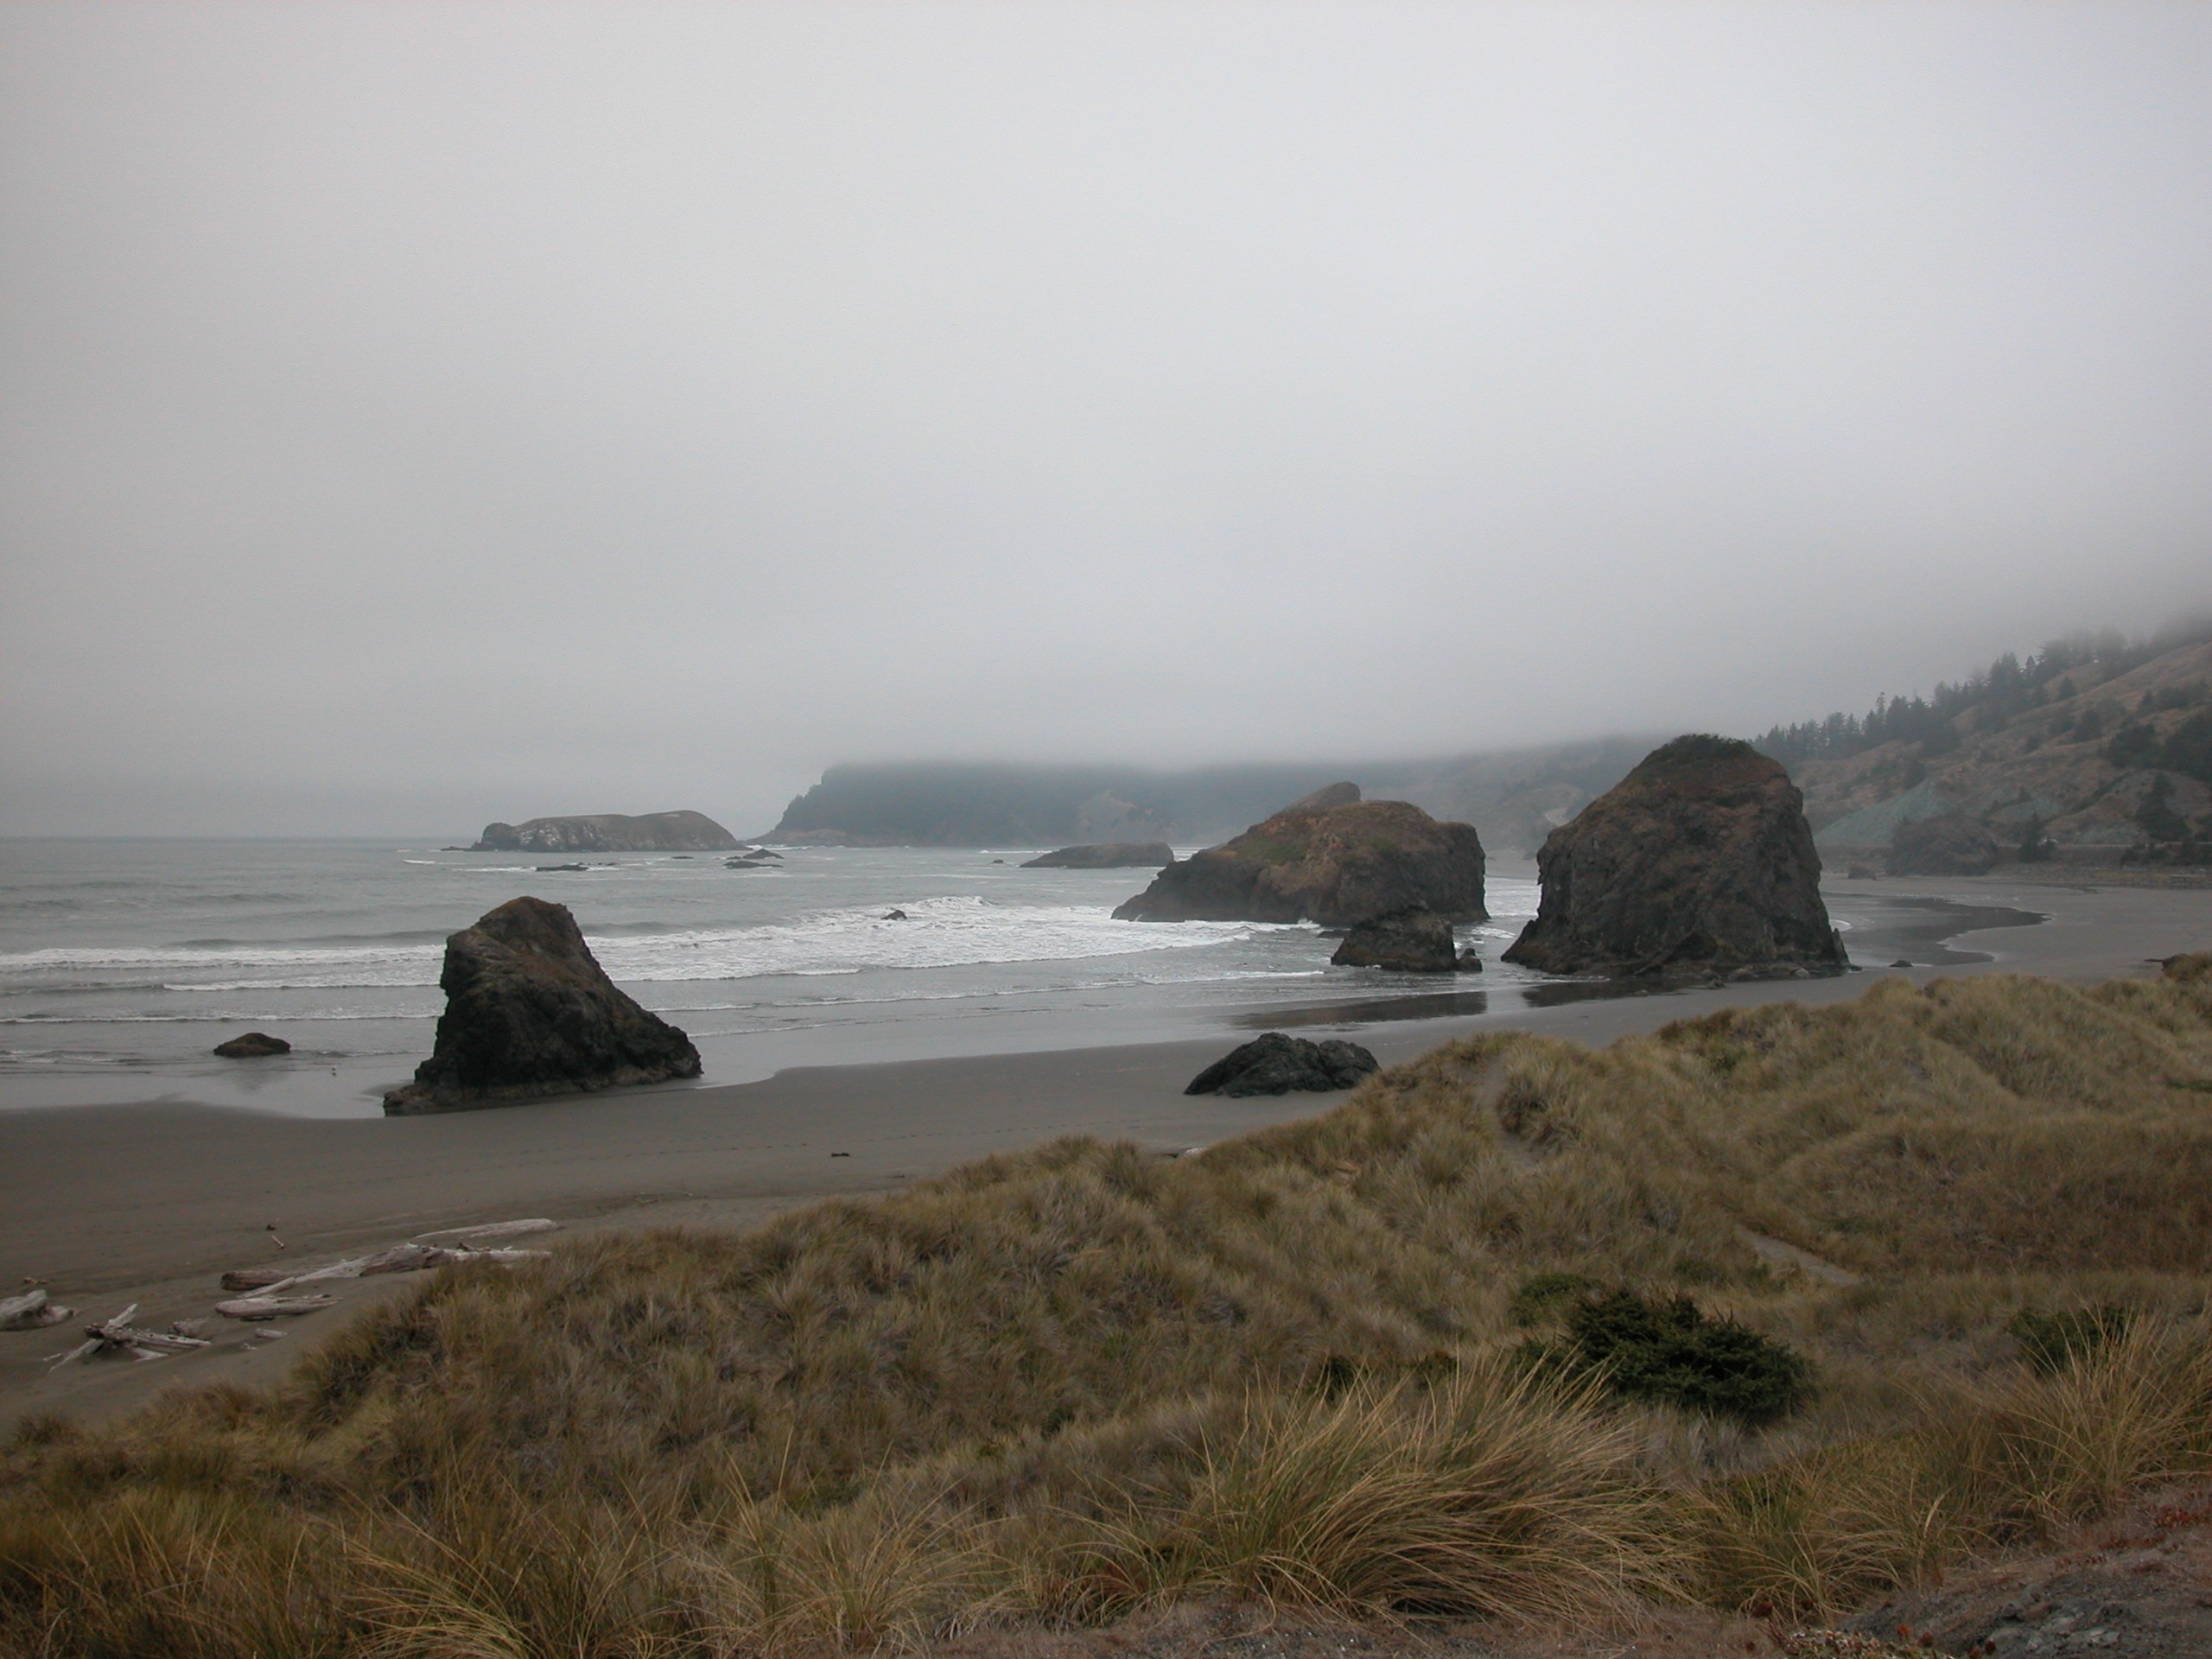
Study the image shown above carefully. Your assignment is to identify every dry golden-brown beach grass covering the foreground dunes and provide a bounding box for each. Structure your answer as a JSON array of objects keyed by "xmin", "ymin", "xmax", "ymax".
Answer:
[{"xmin": 0, "ymin": 957, "xmax": 2212, "ymax": 1659}]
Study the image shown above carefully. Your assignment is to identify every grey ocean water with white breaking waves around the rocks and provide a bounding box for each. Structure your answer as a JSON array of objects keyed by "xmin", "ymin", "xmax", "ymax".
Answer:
[{"xmin": 0, "ymin": 841, "xmax": 2035, "ymax": 1117}]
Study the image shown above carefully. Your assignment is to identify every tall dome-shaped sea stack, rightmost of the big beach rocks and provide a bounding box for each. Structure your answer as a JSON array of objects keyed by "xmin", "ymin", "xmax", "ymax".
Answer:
[{"xmin": 1504, "ymin": 736, "xmax": 1849, "ymax": 978}]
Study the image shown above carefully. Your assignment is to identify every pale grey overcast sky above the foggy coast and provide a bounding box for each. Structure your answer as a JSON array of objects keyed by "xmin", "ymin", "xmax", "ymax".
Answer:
[{"xmin": 0, "ymin": 0, "xmax": 2212, "ymax": 834}]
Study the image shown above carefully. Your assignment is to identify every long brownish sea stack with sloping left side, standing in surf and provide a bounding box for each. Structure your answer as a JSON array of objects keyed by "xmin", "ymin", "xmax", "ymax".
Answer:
[{"xmin": 1115, "ymin": 783, "xmax": 1489, "ymax": 927}]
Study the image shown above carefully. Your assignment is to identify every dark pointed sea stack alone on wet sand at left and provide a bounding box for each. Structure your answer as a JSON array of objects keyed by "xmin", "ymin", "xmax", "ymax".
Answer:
[{"xmin": 385, "ymin": 898, "xmax": 699, "ymax": 1117}]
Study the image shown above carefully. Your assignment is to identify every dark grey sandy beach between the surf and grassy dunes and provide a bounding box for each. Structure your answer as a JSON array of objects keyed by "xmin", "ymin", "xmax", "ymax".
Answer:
[{"xmin": 0, "ymin": 876, "xmax": 2212, "ymax": 1427}]
